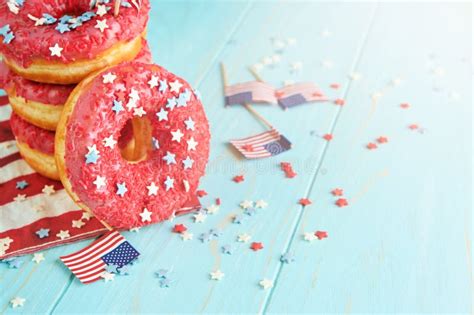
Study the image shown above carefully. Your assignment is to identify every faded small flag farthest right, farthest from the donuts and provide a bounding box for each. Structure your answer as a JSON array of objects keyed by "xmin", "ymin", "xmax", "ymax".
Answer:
[{"xmin": 275, "ymin": 82, "xmax": 328, "ymax": 109}]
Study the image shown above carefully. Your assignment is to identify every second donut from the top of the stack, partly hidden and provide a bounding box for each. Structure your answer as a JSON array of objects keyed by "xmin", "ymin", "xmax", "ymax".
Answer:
[{"xmin": 0, "ymin": 39, "xmax": 151, "ymax": 130}]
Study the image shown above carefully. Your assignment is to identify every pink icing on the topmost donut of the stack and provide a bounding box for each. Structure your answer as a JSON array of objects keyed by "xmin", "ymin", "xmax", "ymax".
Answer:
[{"xmin": 0, "ymin": 0, "xmax": 150, "ymax": 67}]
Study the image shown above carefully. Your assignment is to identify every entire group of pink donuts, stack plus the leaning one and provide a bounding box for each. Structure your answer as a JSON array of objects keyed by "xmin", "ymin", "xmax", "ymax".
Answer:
[{"xmin": 0, "ymin": 0, "xmax": 210, "ymax": 228}]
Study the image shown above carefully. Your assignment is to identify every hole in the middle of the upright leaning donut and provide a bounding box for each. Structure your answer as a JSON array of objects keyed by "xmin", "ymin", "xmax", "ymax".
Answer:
[{"xmin": 118, "ymin": 116, "xmax": 153, "ymax": 163}]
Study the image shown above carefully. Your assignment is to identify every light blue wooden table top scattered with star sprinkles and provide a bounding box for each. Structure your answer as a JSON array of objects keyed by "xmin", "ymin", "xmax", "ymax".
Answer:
[{"xmin": 0, "ymin": 1, "xmax": 473, "ymax": 313}]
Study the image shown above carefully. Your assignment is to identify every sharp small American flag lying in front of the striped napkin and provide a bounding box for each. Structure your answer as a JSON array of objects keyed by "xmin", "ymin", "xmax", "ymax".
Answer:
[{"xmin": 60, "ymin": 231, "xmax": 140, "ymax": 284}]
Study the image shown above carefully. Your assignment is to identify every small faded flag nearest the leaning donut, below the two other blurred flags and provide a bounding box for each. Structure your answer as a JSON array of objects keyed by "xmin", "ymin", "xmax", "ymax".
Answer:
[{"xmin": 230, "ymin": 128, "xmax": 291, "ymax": 159}]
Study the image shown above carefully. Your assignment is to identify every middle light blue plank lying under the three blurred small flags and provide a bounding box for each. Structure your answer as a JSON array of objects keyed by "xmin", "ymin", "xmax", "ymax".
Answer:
[{"xmin": 48, "ymin": 2, "xmax": 373, "ymax": 313}]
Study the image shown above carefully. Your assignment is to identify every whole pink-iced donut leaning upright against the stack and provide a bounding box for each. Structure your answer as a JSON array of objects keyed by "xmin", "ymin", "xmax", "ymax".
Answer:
[{"xmin": 55, "ymin": 62, "xmax": 210, "ymax": 228}]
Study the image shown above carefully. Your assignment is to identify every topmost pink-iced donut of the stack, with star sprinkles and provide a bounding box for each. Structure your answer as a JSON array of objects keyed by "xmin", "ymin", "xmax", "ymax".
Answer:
[{"xmin": 0, "ymin": 0, "xmax": 150, "ymax": 84}]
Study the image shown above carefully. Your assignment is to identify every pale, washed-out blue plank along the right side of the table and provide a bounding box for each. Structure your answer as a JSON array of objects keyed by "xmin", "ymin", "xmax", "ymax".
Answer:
[{"xmin": 266, "ymin": 3, "xmax": 473, "ymax": 313}]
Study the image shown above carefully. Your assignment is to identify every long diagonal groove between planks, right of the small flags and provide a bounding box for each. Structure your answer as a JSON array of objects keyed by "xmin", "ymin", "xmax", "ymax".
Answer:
[{"xmin": 259, "ymin": 2, "xmax": 378, "ymax": 314}]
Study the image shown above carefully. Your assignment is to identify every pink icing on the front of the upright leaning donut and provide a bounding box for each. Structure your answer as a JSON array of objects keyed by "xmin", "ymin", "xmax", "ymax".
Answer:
[{"xmin": 65, "ymin": 63, "xmax": 210, "ymax": 228}]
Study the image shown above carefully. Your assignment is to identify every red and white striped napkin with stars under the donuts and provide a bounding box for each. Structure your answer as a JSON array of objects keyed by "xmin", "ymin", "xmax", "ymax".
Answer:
[{"xmin": 0, "ymin": 96, "xmax": 201, "ymax": 259}]
